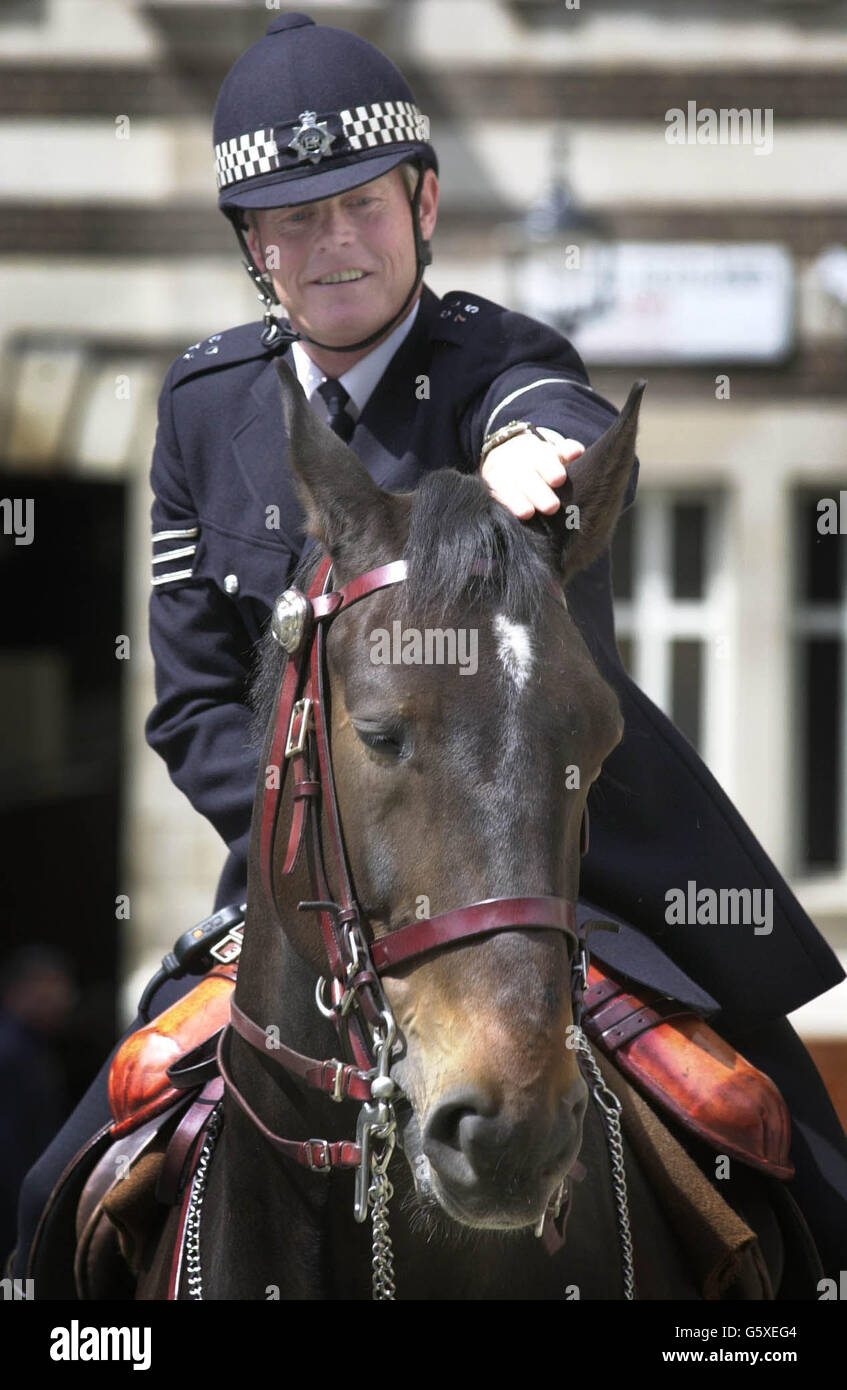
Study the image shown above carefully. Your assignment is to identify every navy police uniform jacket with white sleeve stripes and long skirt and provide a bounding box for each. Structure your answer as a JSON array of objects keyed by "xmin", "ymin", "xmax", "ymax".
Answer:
[{"xmin": 146, "ymin": 286, "xmax": 843, "ymax": 1026}]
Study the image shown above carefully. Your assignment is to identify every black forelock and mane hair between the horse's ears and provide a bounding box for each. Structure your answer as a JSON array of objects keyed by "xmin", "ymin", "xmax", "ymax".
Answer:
[{"xmin": 249, "ymin": 468, "xmax": 551, "ymax": 745}]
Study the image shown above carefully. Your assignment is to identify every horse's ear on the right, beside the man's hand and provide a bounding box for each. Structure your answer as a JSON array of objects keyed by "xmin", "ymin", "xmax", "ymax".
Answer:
[{"xmin": 533, "ymin": 381, "xmax": 647, "ymax": 584}]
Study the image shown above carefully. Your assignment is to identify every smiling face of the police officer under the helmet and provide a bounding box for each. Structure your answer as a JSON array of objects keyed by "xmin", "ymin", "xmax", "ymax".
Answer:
[{"xmin": 248, "ymin": 168, "xmax": 438, "ymax": 345}]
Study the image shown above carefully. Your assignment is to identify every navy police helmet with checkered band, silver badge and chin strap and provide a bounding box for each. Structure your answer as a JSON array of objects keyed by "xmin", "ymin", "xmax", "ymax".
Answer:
[{"xmin": 213, "ymin": 14, "xmax": 438, "ymax": 352}]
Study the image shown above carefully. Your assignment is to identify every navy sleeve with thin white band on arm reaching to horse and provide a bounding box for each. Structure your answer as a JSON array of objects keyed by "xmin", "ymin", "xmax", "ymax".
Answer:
[{"xmin": 463, "ymin": 311, "xmax": 638, "ymax": 510}]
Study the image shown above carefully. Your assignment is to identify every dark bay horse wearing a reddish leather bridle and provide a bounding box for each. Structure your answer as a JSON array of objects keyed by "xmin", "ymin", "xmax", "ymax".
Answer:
[{"xmin": 139, "ymin": 363, "xmax": 784, "ymax": 1300}]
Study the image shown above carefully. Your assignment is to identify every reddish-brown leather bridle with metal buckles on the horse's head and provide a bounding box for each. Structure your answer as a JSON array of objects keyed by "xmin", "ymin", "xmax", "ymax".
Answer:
[{"xmin": 217, "ymin": 547, "xmax": 594, "ymax": 1200}]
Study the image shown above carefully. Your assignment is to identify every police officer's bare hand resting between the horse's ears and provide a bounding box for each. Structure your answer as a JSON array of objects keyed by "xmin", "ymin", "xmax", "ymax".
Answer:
[{"xmin": 480, "ymin": 425, "xmax": 586, "ymax": 521}]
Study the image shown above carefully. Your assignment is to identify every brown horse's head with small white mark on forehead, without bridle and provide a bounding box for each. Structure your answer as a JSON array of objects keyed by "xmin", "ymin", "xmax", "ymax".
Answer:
[{"xmin": 267, "ymin": 364, "xmax": 643, "ymax": 1229}]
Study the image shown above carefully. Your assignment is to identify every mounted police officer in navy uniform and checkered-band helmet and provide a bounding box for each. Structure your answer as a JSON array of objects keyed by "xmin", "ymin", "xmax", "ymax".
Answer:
[{"xmin": 15, "ymin": 14, "xmax": 847, "ymax": 1276}]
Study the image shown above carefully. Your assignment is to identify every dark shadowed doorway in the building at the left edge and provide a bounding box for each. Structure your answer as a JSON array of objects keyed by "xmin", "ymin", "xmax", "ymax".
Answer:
[{"xmin": 0, "ymin": 473, "xmax": 127, "ymax": 1102}]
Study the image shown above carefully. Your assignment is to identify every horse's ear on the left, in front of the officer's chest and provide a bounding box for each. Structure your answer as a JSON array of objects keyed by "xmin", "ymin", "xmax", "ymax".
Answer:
[{"xmin": 274, "ymin": 357, "xmax": 389, "ymax": 573}]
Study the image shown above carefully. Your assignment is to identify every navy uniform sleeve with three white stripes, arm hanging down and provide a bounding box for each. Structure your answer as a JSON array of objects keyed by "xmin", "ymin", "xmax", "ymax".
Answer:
[{"xmin": 146, "ymin": 368, "xmax": 259, "ymax": 860}]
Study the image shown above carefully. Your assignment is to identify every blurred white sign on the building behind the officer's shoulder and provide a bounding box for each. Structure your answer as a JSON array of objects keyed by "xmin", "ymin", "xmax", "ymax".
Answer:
[{"xmin": 516, "ymin": 242, "xmax": 794, "ymax": 364}]
